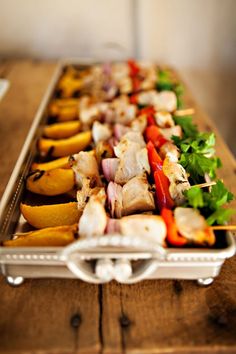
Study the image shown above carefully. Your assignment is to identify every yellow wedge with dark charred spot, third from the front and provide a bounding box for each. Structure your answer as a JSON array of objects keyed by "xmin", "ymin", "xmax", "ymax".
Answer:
[{"xmin": 26, "ymin": 168, "xmax": 75, "ymax": 196}]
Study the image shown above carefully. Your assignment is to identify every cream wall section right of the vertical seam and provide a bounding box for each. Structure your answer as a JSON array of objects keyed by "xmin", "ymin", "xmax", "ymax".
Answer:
[{"xmin": 138, "ymin": 0, "xmax": 236, "ymax": 69}]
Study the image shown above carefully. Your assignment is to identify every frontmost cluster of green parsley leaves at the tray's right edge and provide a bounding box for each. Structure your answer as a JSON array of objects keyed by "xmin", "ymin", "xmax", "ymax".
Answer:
[{"xmin": 184, "ymin": 180, "xmax": 235, "ymax": 225}]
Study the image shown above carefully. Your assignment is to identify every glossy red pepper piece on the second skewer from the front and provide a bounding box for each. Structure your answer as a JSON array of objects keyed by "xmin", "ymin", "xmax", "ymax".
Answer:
[{"xmin": 154, "ymin": 170, "xmax": 175, "ymax": 211}]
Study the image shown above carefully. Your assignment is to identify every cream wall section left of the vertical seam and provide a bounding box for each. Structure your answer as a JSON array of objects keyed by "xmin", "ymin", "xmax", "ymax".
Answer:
[{"xmin": 0, "ymin": 0, "xmax": 133, "ymax": 58}]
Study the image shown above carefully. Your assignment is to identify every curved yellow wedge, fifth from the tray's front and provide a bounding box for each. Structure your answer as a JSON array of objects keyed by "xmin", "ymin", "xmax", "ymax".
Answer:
[{"xmin": 38, "ymin": 131, "xmax": 92, "ymax": 157}]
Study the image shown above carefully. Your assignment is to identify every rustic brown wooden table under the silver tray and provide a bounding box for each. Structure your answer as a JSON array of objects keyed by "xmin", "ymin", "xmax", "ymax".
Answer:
[{"xmin": 0, "ymin": 60, "xmax": 236, "ymax": 354}]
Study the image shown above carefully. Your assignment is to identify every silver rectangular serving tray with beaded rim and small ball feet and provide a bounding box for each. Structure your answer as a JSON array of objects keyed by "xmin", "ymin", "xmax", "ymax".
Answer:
[{"xmin": 0, "ymin": 59, "xmax": 235, "ymax": 286}]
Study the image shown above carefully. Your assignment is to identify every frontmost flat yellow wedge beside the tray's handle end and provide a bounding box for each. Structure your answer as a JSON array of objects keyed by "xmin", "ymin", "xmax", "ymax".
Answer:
[{"xmin": 3, "ymin": 224, "xmax": 78, "ymax": 247}]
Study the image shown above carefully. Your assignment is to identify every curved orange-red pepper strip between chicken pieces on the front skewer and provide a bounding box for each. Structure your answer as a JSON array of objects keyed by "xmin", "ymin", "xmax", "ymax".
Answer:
[{"xmin": 161, "ymin": 208, "xmax": 188, "ymax": 247}]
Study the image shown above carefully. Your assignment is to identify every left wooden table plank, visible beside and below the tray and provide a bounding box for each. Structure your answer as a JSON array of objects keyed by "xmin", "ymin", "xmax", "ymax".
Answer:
[{"xmin": 0, "ymin": 60, "xmax": 100, "ymax": 354}]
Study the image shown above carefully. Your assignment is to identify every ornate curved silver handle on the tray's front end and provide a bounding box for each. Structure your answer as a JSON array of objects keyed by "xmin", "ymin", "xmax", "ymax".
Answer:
[{"xmin": 59, "ymin": 234, "xmax": 166, "ymax": 284}]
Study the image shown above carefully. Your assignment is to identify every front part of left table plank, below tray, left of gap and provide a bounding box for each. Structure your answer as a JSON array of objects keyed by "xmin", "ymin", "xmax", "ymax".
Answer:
[{"xmin": 0, "ymin": 277, "xmax": 100, "ymax": 354}]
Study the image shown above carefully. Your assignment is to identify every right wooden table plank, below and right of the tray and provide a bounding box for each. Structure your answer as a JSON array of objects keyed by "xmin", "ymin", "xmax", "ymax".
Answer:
[{"xmin": 103, "ymin": 70, "xmax": 236, "ymax": 354}]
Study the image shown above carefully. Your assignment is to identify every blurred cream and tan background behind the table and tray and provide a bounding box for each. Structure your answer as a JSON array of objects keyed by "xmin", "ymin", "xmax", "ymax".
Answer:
[{"xmin": 0, "ymin": 0, "xmax": 236, "ymax": 154}]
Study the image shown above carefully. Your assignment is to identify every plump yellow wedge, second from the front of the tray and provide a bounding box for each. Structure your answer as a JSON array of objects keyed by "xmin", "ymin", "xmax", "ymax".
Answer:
[{"xmin": 20, "ymin": 202, "xmax": 82, "ymax": 229}]
